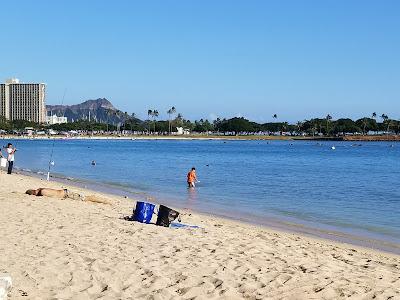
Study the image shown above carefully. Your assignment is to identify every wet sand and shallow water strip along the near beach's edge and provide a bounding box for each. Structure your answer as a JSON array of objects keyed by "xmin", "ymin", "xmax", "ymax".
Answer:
[{"xmin": 14, "ymin": 170, "xmax": 400, "ymax": 255}]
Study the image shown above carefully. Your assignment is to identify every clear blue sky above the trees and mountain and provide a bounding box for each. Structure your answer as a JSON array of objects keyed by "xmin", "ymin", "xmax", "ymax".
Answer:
[{"xmin": 0, "ymin": 0, "xmax": 400, "ymax": 122}]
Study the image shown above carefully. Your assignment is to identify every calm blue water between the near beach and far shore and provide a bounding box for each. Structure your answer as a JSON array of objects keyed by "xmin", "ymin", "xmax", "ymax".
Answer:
[{"xmin": 7, "ymin": 139, "xmax": 400, "ymax": 244}]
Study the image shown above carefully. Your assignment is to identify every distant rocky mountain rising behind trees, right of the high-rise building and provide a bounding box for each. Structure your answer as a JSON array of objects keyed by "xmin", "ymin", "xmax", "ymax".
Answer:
[{"xmin": 46, "ymin": 98, "xmax": 136, "ymax": 124}]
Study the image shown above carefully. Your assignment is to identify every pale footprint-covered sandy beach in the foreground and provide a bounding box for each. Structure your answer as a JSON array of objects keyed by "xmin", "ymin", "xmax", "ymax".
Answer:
[{"xmin": 0, "ymin": 171, "xmax": 400, "ymax": 299}]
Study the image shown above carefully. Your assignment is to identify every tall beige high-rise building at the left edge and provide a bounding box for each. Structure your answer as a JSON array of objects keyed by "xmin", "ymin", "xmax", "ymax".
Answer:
[{"xmin": 0, "ymin": 78, "xmax": 46, "ymax": 123}]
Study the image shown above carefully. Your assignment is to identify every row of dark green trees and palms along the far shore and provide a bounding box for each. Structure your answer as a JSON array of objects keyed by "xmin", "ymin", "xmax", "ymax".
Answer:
[{"xmin": 0, "ymin": 111, "xmax": 400, "ymax": 136}]
